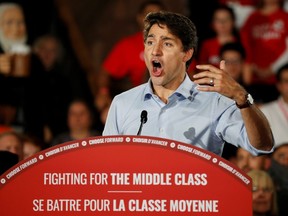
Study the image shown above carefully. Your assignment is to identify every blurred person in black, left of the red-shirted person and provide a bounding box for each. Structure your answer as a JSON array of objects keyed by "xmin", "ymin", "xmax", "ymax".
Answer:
[{"xmin": 30, "ymin": 34, "xmax": 74, "ymax": 143}]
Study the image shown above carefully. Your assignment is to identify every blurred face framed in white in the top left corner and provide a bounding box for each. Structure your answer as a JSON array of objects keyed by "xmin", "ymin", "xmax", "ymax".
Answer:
[{"xmin": 0, "ymin": 8, "xmax": 26, "ymax": 41}]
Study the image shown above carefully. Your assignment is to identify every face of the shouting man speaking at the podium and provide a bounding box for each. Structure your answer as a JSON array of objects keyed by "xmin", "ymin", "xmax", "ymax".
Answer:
[{"xmin": 144, "ymin": 24, "xmax": 193, "ymax": 90}]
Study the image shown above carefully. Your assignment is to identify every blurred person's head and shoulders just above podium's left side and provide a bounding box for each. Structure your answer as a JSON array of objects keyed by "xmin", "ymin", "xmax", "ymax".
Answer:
[{"xmin": 51, "ymin": 99, "xmax": 101, "ymax": 146}]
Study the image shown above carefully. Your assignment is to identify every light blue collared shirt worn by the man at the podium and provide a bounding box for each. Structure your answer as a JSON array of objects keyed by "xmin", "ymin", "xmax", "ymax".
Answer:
[{"xmin": 103, "ymin": 75, "xmax": 270, "ymax": 156}]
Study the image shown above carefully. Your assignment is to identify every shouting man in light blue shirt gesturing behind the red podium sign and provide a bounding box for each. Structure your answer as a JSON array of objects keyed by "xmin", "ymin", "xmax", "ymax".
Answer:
[{"xmin": 103, "ymin": 12, "xmax": 274, "ymax": 155}]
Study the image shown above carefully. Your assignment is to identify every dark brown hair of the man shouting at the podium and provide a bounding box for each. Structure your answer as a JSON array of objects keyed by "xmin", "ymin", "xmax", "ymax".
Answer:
[{"xmin": 143, "ymin": 11, "xmax": 198, "ymax": 68}]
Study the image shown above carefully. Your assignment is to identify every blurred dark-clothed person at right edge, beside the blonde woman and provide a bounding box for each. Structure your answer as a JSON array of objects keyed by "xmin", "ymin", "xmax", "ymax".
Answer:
[{"xmin": 268, "ymin": 143, "xmax": 288, "ymax": 216}]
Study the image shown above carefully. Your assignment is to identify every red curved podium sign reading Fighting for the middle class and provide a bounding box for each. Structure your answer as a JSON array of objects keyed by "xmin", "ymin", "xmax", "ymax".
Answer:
[{"xmin": 0, "ymin": 136, "xmax": 252, "ymax": 216}]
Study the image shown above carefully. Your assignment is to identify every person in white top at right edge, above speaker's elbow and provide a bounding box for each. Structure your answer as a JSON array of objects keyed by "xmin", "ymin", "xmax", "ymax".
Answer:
[{"xmin": 260, "ymin": 63, "xmax": 288, "ymax": 146}]
